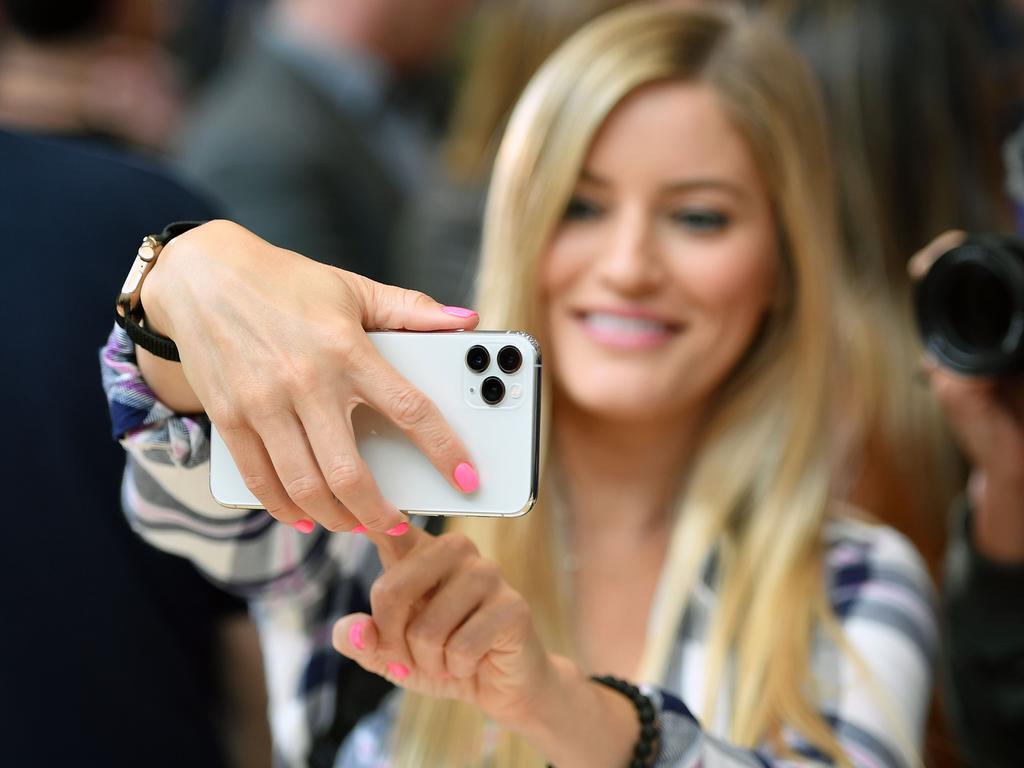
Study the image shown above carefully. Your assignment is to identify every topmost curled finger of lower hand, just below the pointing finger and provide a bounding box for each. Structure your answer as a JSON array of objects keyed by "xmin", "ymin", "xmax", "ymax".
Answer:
[{"xmin": 370, "ymin": 536, "xmax": 477, "ymax": 659}]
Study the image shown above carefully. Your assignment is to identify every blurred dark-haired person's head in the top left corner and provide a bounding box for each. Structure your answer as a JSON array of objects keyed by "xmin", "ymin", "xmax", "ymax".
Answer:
[{"xmin": 0, "ymin": 0, "xmax": 181, "ymax": 151}]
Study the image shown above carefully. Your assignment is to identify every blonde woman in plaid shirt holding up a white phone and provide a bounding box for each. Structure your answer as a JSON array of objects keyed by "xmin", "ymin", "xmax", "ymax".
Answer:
[{"xmin": 105, "ymin": 5, "xmax": 935, "ymax": 768}]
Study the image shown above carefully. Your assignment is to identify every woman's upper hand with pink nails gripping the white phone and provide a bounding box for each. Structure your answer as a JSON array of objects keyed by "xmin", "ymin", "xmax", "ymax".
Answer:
[{"xmin": 139, "ymin": 221, "xmax": 479, "ymax": 535}]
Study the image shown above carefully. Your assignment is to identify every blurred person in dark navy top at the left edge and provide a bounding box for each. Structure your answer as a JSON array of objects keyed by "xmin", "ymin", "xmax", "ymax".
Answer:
[{"xmin": 0, "ymin": 128, "xmax": 270, "ymax": 768}]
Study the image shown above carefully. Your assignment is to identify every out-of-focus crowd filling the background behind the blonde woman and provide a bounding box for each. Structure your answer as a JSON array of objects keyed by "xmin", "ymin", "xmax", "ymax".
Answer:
[{"xmin": 0, "ymin": 0, "xmax": 1024, "ymax": 768}]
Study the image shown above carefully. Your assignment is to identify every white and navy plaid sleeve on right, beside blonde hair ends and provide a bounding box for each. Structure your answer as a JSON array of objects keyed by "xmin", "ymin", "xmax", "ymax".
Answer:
[{"xmin": 645, "ymin": 523, "xmax": 938, "ymax": 768}]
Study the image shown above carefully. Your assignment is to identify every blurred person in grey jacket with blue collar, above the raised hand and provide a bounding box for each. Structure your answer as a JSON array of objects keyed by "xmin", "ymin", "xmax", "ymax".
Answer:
[{"xmin": 180, "ymin": 0, "xmax": 469, "ymax": 281}]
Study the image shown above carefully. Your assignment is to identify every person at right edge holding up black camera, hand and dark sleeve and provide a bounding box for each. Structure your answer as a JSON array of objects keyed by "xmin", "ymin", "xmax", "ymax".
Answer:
[{"xmin": 910, "ymin": 231, "xmax": 1024, "ymax": 768}]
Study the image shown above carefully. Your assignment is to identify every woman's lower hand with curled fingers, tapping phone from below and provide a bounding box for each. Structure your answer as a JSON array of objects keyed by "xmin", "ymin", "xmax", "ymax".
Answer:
[{"xmin": 334, "ymin": 528, "xmax": 556, "ymax": 726}]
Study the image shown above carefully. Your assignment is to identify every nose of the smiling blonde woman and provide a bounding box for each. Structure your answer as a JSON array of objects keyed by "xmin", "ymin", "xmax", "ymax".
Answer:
[{"xmin": 600, "ymin": 206, "xmax": 666, "ymax": 296}]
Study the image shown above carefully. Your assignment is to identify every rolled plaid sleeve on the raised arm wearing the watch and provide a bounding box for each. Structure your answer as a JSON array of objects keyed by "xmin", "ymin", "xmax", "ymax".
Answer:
[{"xmin": 100, "ymin": 326, "xmax": 348, "ymax": 602}]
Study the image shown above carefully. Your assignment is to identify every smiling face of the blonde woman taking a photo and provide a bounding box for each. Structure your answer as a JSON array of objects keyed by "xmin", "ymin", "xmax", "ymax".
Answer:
[{"xmin": 541, "ymin": 82, "xmax": 778, "ymax": 428}]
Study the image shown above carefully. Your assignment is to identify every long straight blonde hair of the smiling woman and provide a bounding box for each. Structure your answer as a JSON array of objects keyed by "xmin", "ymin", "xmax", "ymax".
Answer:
[{"xmin": 393, "ymin": 4, "xmax": 872, "ymax": 767}]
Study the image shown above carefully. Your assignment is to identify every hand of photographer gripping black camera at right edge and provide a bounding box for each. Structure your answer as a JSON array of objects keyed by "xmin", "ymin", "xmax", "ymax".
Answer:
[{"xmin": 909, "ymin": 231, "xmax": 1024, "ymax": 563}]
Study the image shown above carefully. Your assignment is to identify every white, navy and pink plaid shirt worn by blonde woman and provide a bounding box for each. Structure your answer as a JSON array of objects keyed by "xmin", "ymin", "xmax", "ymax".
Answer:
[{"xmin": 100, "ymin": 328, "xmax": 937, "ymax": 768}]
